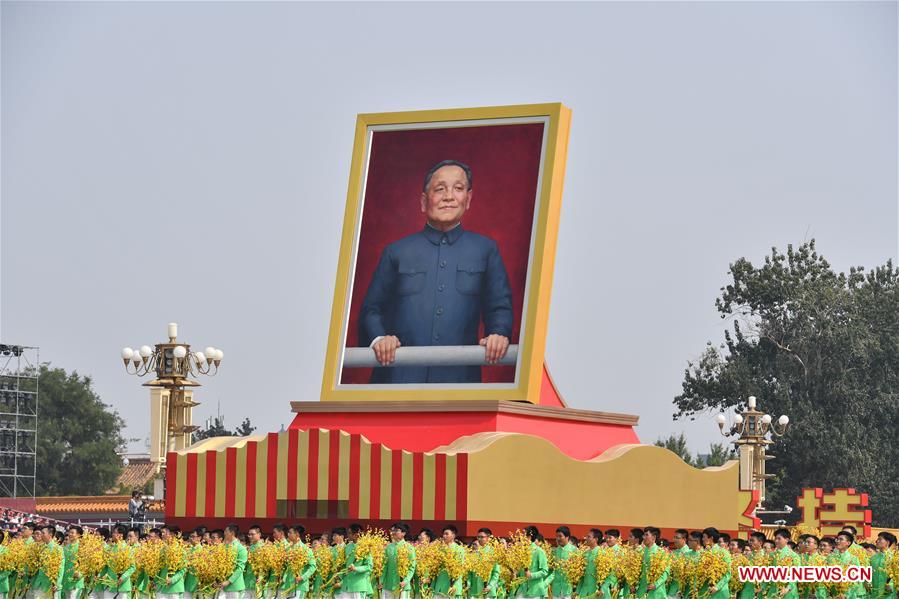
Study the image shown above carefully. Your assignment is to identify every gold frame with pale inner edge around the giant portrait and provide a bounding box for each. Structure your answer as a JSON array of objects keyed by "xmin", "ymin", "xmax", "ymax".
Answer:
[{"xmin": 321, "ymin": 103, "xmax": 571, "ymax": 404}]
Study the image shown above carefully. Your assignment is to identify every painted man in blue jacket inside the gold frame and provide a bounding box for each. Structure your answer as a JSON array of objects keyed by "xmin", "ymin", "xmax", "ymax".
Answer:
[{"xmin": 359, "ymin": 160, "xmax": 512, "ymax": 383}]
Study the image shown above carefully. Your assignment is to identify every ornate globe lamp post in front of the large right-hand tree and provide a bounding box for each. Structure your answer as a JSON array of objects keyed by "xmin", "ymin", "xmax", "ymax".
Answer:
[{"xmin": 715, "ymin": 396, "xmax": 790, "ymax": 510}]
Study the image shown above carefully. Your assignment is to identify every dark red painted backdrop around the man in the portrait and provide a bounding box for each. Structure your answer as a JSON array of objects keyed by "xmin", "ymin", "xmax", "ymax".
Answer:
[{"xmin": 341, "ymin": 123, "xmax": 543, "ymax": 384}]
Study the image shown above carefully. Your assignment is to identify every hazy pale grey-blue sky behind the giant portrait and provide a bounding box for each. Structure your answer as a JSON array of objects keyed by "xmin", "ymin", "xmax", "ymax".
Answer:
[{"xmin": 0, "ymin": 2, "xmax": 899, "ymax": 458}]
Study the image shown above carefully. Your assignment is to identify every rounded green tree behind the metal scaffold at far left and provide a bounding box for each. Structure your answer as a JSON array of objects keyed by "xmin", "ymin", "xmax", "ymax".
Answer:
[{"xmin": 35, "ymin": 364, "xmax": 125, "ymax": 495}]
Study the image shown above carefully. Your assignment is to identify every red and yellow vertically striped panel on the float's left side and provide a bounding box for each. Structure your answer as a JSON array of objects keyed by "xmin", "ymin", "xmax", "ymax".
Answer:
[{"xmin": 166, "ymin": 429, "xmax": 468, "ymax": 520}]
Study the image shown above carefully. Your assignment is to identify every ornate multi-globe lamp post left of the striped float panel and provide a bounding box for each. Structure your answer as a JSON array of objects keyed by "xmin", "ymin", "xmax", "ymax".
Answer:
[{"xmin": 122, "ymin": 323, "xmax": 225, "ymax": 497}]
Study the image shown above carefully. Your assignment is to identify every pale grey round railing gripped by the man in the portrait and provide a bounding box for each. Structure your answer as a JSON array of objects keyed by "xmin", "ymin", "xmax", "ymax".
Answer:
[{"xmin": 343, "ymin": 345, "xmax": 518, "ymax": 368}]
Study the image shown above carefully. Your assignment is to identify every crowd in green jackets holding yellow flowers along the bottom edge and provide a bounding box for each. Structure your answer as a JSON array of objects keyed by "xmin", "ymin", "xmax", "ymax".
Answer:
[{"xmin": 0, "ymin": 522, "xmax": 899, "ymax": 599}]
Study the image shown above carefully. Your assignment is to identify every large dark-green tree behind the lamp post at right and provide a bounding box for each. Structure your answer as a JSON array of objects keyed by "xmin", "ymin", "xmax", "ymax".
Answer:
[{"xmin": 674, "ymin": 241, "xmax": 899, "ymax": 526}]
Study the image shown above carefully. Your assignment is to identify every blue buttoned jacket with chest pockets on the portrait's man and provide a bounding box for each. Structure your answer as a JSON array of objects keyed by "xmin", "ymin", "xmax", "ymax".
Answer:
[{"xmin": 359, "ymin": 225, "xmax": 512, "ymax": 383}]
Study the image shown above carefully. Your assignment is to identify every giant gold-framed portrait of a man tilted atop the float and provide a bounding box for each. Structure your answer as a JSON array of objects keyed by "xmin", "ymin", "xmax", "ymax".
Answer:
[{"xmin": 321, "ymin": 104, "xmax": 571, "ymax": 403}]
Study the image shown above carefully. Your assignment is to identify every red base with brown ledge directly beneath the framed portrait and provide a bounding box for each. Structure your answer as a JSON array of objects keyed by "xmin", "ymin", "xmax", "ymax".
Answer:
[{"xmin": 290, "ymin": 368, "xmax": 640, "ymax": 460}]
